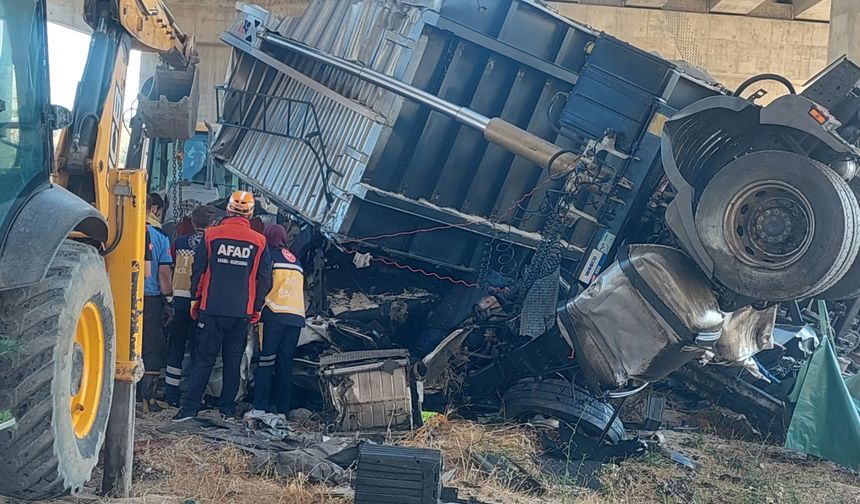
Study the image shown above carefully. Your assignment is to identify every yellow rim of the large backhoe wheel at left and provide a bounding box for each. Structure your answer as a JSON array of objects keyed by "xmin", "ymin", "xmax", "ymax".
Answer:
[{"xmin": 70, "ymin": 302, "xmax": 105, "ymax": 438}]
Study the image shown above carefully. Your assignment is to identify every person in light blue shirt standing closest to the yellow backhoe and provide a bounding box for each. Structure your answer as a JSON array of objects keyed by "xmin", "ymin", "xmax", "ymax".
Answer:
[{"xmin": 143, "ymin": 193, "xmax": 173, "ymax": 411}]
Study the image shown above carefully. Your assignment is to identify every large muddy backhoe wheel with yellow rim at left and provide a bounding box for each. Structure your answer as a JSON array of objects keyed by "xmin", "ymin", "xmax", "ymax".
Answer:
[{"xmin": 0, "ymin": 240, "xmax": 115, "ymax": 500}]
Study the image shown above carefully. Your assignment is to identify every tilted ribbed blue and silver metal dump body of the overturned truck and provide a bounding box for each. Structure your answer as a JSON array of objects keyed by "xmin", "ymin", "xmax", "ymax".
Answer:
[{"xmin": 216, "ymin": 0, "xmax": 596, "ymax": 272}]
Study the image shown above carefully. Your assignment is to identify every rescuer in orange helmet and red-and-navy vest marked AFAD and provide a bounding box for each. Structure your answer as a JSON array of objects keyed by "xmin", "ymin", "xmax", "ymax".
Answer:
[{"xmin": 173, "ymin": 191, "xmax": 272, "ymax": 421}]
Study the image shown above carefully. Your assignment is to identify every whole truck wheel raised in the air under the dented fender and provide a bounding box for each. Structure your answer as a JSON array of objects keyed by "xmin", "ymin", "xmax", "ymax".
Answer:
[{"xmin": 695, "ymin": 151, "xmax": 860, "ymax": 301}]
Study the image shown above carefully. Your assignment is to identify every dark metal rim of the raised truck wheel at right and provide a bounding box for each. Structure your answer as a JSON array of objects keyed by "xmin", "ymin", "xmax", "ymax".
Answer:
[{"xmin": 725, "ymin": 181, "xmax": 815, "ymax": 269}]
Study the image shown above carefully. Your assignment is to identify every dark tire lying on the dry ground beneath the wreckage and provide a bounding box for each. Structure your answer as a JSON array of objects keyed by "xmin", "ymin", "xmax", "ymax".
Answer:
[{"xmin": 503, "ymin": 379, "xmax": 625, "ymax": 445}]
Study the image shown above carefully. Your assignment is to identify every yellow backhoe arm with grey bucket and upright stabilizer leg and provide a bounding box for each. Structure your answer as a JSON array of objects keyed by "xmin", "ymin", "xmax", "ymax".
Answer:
[{"xmin": 47, "ymin": 0, "xmax": 198, "ymax": 495}]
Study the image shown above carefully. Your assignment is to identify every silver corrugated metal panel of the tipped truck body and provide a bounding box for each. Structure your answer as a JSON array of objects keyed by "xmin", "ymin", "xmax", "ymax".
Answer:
[{"xmin": 213, "ymin": 0, "xmax": 434, "ymax": 228}]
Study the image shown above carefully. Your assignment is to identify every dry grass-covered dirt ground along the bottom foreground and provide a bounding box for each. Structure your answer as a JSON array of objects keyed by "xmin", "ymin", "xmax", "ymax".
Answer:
[{"xmin": 8, "ymin": 404, "xmax": 860, "ymax": 504}]
